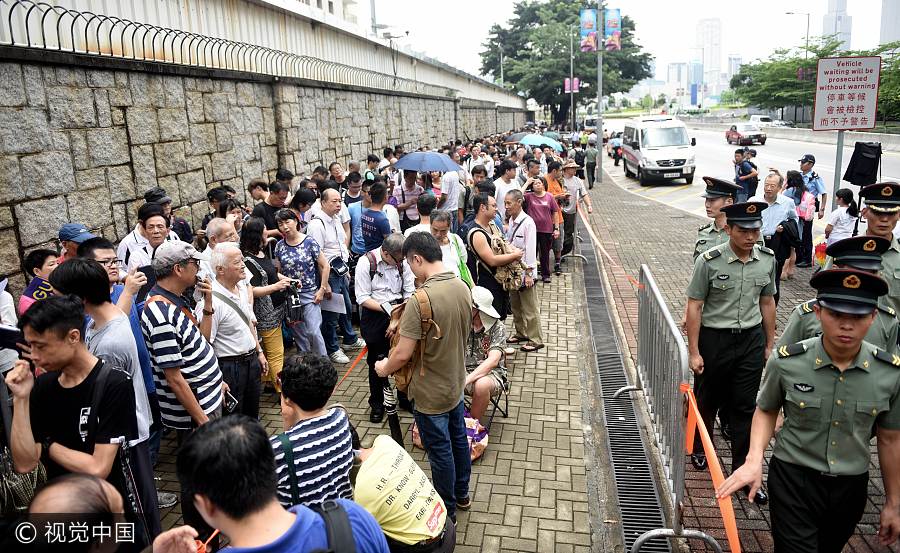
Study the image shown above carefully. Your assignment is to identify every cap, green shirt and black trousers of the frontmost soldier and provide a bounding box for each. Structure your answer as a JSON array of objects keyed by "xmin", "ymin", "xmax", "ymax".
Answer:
[{"xmin": 757, "ymin": 269, "xmax": 900, "ymax": 553}]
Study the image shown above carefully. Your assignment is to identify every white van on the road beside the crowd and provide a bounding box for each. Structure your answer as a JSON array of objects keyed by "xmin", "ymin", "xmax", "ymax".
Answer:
[{"xmin": 622, "ymin": 116, "xmax": 697, "ymax": 186}]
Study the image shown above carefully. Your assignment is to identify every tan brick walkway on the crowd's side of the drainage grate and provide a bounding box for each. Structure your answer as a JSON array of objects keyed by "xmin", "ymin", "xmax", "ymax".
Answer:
[{"xmin": 157, "ymin": 274, "xmax": 593, "ymax": 553}]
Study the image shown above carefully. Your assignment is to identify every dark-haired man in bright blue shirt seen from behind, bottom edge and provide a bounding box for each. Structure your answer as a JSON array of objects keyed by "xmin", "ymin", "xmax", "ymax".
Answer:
[{"xmin": 176, "ymin": 415, "xmax": 388, "ymax": 553}]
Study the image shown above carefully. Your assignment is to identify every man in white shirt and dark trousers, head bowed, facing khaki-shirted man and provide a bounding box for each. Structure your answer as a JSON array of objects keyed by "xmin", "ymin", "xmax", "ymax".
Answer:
[{"xmin": 355, "ymin": 233, "xmax": 418, "ymax": 423}]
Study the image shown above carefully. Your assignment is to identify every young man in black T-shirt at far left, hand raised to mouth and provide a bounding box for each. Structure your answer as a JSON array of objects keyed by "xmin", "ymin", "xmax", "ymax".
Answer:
[{"xmin": 6, "ymin": 296, "xmax": 147, "ymax": 539}]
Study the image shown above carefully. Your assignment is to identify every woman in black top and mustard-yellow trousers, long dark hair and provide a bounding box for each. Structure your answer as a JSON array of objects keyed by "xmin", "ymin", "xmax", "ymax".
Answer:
[{"xmin": 240, "ymin": 217, "xmax": 291, "ymax": 392}]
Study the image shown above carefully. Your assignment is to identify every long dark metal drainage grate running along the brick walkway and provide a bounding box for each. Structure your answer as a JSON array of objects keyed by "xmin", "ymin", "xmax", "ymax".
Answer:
[{"xmin": 579, "ymin": 222, "xmax": 671, "ymax": 553}]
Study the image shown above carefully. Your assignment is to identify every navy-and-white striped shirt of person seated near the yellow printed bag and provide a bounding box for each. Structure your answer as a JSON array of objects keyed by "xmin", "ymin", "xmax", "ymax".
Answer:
[{"xmin": 269, "ymin": 408, "xmax": 353, "ymax": 507}]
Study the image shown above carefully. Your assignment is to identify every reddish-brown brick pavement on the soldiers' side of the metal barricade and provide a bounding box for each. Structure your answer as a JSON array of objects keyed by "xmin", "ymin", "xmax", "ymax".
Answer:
[{"xmin": 591, "ymin": 152, "xmax": 898, "ymax": 552}]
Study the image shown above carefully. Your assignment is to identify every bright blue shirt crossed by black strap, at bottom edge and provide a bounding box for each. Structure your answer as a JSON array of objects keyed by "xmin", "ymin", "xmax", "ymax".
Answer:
[{"xmin": 228, "ymin": 499, "xmax": 389, "ymax": 553}]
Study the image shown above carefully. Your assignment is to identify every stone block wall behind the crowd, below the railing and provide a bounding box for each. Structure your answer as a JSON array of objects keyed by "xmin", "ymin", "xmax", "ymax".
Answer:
[{"xmin": 0, "ymin": 62, "xmax": 526, "ymax": 294}]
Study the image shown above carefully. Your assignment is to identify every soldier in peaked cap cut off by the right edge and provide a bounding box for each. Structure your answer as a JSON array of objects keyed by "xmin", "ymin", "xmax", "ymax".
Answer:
[{"xmin": 859, "ymin": 182, "xmax": 900, "ymax": 313}]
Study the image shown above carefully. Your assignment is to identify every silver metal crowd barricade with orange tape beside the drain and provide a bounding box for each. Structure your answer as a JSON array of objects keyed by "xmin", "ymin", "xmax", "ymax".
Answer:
[{"xmin": 614, "ymin": 265, "xmax": 734, "ymax": 553}]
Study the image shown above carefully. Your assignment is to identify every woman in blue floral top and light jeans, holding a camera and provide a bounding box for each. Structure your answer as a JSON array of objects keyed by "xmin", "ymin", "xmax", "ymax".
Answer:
[{"xmin": 275, "ymin": 209, "xmax": 331, "ymax": 356}]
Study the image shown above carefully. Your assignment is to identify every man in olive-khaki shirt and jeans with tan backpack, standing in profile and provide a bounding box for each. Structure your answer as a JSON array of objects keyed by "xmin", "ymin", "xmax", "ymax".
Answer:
[{"xmin": 375, "ymin": 232, "xmax": 472, "ymax": 521}]
